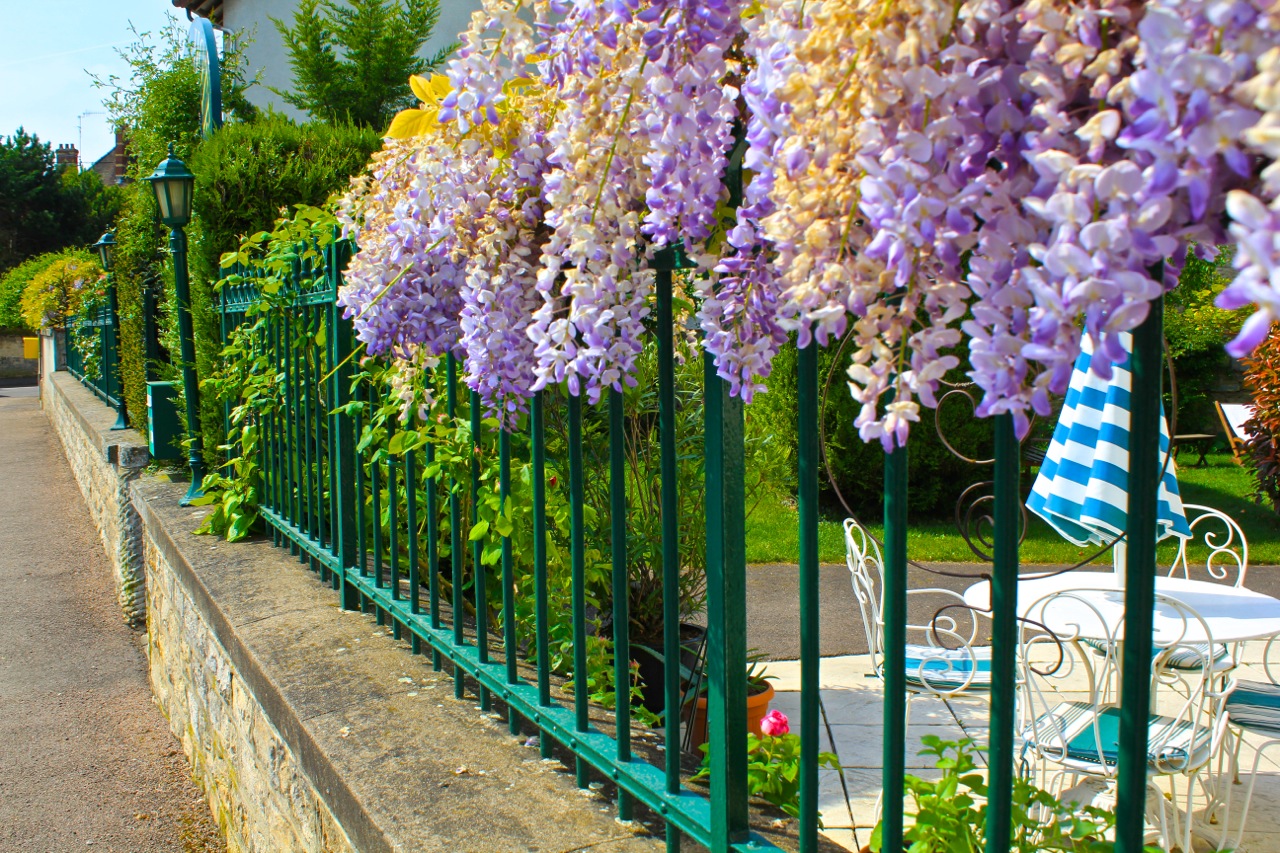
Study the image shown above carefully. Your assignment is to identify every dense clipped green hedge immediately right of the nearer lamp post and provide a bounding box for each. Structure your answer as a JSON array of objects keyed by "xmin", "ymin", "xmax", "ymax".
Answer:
[{"xmin": 183, "ymin": 115, "xmax": 381, "ymax": 464}]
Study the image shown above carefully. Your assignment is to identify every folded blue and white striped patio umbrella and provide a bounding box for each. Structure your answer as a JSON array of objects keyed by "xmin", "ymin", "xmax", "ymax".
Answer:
[{"xmin": 1027, "ymin": 334, "xmax": 1192, "ymax": 546}]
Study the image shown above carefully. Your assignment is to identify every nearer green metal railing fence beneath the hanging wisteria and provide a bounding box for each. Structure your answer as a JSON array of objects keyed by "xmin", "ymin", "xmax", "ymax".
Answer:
[{"xmin": 221, "ymin": 241, "xmax": 1161, "ymax": 853}]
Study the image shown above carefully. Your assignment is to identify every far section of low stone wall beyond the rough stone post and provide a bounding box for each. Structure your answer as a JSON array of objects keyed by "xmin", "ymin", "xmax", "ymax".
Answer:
[{"xmin": 40, "ymin": 371, "xmax": 151, "ymax": 625}]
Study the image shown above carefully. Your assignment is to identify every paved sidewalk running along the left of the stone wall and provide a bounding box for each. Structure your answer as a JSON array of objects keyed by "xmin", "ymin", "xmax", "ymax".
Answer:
[{"xmin": 0, "ymin": 388, "xmax": 225, "ymax": 853}]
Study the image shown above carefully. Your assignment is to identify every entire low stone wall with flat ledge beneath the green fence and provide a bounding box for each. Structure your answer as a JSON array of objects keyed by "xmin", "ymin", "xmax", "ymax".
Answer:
[{"xmin": 42, "ymin": 373, "xmax": 662, "ymax": 853}]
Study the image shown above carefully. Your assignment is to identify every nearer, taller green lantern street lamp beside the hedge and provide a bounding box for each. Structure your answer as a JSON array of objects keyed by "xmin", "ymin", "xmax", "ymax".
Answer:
[{"xmin": 147, "ymin": 142, "xmax": 205, "ymax": 506}]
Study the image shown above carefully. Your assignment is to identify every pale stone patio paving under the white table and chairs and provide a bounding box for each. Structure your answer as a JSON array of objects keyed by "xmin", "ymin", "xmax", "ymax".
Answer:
[{"xmin": 768, "ymin": 643, "xmax": 1280, "ymax": 853}]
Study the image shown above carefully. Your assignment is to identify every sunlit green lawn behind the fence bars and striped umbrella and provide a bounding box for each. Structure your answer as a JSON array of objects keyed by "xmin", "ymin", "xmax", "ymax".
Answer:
[{"xmin": 746, "ymin": 452, "xmax": 1280, "ymax": 566}]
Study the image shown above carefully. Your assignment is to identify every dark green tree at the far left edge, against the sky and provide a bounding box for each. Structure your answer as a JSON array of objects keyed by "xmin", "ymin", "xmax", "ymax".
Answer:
[{"xmin": 0, "ymin": 128, "xmax": 120, "ymax": 270}]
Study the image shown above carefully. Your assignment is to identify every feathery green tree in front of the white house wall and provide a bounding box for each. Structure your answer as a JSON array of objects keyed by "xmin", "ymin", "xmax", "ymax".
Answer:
[{"xmin": 271, "ymin": 0, "xmax": 457, "ymax": 131}]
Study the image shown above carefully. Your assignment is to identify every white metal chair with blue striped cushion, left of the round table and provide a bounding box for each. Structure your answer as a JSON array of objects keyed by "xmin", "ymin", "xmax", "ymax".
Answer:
[{"xmin": 845, "ymin": 519, "xmax": 991, "ymax": 710}]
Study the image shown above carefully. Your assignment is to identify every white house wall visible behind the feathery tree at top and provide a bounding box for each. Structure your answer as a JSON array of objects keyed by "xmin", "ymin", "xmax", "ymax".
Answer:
[{"xmin": 223, "ymin": 0, "xmax": 480, "ymax": 120}]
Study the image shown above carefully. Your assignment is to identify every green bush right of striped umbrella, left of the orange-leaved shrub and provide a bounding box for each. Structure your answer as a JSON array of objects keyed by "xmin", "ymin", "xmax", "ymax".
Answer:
[{"xmin": 1165, "ymin": 247, "xmax": 1249, "ymax": 434}]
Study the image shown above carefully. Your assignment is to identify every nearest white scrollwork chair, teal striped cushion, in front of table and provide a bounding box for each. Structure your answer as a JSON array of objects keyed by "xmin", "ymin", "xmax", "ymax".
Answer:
[{"xmin": 1019, "ymin": 589, "xmax": 1230, "ymax": 853}]
